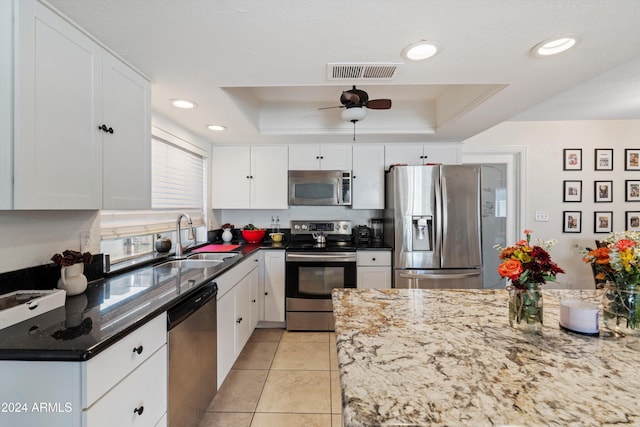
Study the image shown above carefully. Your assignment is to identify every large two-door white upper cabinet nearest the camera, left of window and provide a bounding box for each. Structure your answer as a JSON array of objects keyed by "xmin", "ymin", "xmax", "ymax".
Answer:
[{"xmin": 8, "ymin": 0, "xmax": 151, "ymax": 209}]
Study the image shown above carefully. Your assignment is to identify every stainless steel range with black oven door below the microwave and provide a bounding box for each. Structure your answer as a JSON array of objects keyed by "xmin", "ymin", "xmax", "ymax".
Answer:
[{"xmin": 285, "ymin": 221, "xmax": 356, "ymax": 331}]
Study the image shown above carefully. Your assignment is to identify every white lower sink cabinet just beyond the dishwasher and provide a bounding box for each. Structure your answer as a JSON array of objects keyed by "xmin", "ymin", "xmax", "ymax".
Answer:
[{"xmin": 215, "ymin": 253, "xmax": 260, "ymax": 388}]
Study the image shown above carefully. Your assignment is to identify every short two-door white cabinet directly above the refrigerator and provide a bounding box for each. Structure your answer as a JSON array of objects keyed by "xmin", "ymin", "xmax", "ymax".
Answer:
[{"xmin": 384, "ymin": 142, "xmax": 462, "ymax": 169}]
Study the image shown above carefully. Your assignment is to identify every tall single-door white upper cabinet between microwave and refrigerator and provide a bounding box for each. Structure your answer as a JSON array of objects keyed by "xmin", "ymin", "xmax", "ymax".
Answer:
[{"xmin": 351, "ymin": 144, "xmax": 384, "ymax": 209}]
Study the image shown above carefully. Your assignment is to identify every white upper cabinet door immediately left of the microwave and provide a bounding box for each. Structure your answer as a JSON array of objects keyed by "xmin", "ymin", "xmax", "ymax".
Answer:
[{"xmin": 250, "ymin": 146, "xmax": 289, "ymax": 209}]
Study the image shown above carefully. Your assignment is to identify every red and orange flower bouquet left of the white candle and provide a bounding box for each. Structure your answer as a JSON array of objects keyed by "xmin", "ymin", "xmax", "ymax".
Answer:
[{"xmin": 496, "ymin": 230, "xmax": 564, "ymax": 290}]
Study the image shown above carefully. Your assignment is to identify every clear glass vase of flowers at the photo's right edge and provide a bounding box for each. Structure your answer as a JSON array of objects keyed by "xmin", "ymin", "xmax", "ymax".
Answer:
[{"xmin": 602, "ymin": 283, "xmax": 640, "ymax": 336}]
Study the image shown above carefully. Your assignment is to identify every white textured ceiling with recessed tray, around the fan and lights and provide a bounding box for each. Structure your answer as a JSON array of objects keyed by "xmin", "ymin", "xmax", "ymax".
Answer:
[{"xmin": 49, "ymin": 0, "xmax": 640, "ymax": 143}]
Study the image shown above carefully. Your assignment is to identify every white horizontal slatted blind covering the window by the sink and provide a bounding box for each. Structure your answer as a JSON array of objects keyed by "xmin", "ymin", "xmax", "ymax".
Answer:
[{"xmin": 100, "ymin": 134, "xmax": 206, "ymax": 240}]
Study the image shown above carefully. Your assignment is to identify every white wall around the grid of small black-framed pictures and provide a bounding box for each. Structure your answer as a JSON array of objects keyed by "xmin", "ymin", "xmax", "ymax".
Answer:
[{"xmin": 463, "ymin": 120, "xmax": 640, "ymax": 289}]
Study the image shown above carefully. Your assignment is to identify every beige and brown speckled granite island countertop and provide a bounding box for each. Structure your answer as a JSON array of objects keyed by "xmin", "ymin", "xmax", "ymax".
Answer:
[{"xmin": 333, "ymin": 289, "xmax": 640, "ymax": 427}]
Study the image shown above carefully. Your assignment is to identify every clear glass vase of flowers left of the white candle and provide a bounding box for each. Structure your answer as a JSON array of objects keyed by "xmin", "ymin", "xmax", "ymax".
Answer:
[{"xmin": 509, "ymin": 283, "xmax": 542, "ymax": 333}]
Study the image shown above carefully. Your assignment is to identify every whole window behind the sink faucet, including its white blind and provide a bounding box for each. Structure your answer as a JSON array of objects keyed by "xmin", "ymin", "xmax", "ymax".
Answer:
[{"xmin": 100, "ymin": 128, "xmax": 207, "ymax": 263}]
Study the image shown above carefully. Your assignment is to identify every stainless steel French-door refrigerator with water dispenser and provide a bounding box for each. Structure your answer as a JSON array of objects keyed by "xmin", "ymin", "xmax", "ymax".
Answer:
[{"xmin": 384, "ymin": 165, "xmax": 482, "ymax": 289}]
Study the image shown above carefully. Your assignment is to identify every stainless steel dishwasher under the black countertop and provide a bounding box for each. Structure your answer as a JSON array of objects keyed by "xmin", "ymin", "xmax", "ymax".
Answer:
[{"xmin": 167, "ymin": 281, "xmax": 218, "ymax": 427}]
